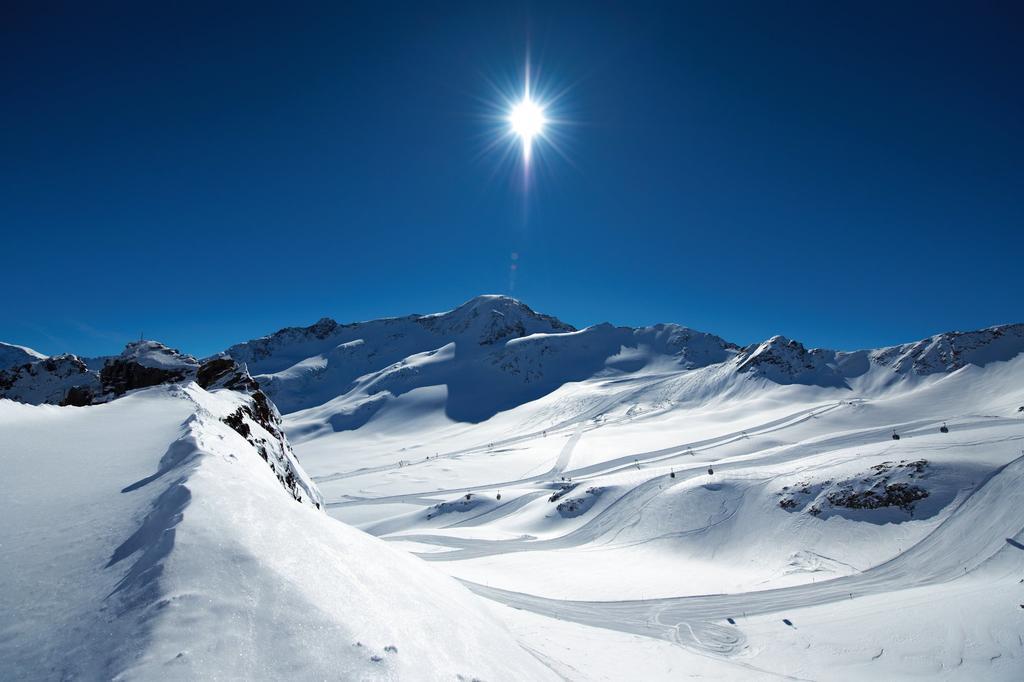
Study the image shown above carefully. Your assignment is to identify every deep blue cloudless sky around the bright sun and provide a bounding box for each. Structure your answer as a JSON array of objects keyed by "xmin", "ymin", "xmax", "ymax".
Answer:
[{"xmin": 0, "ymin": 2, "xmax": 1024, "ymax": 354}]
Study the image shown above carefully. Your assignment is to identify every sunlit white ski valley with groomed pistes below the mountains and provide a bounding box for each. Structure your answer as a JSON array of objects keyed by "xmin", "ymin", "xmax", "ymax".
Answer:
[{"xmin": 296, "ymin": 368, "xmax": 1024, "ymax": 680}]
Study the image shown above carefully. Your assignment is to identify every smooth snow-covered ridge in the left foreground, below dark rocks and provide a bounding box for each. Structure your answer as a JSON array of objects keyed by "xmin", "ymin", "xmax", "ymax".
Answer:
[{"xmin": 0, "ymin": 383, "xmax": 553, "ymax": 680}]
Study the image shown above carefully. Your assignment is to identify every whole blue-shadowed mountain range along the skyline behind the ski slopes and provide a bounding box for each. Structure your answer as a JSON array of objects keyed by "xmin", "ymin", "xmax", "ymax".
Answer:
[{"xmin": 218, "ymin": 296, "xmax": 1024, "ymax": 430}]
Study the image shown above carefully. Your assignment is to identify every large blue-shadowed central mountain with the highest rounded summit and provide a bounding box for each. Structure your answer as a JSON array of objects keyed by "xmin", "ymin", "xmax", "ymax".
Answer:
[{"xmin": 225, "ymin": 296, "xmax": 736, "ymax": 431}]
